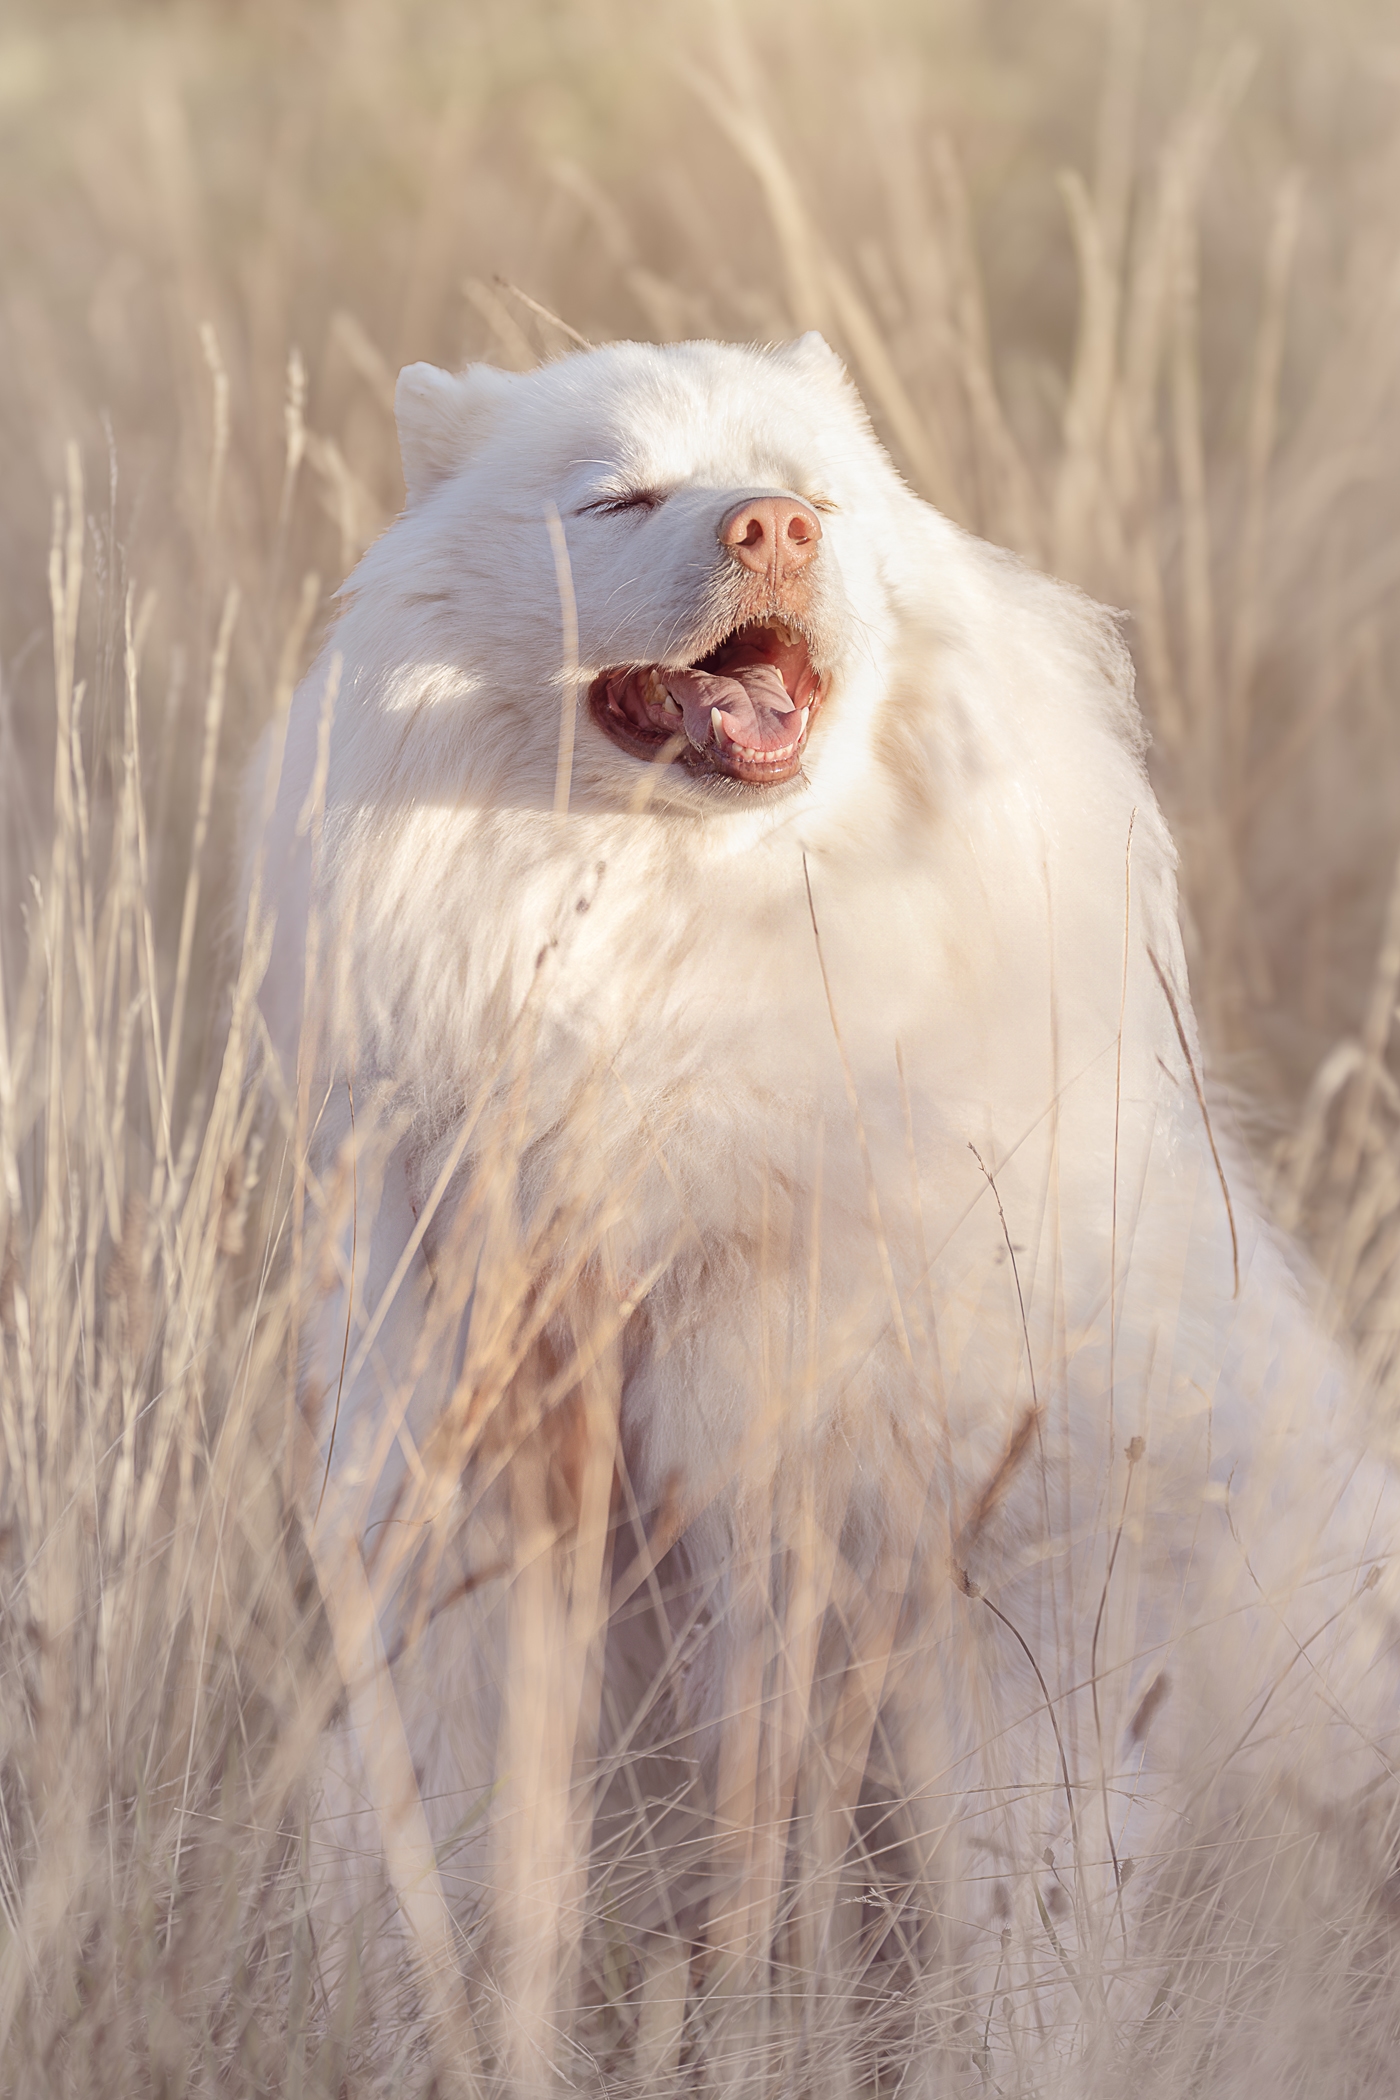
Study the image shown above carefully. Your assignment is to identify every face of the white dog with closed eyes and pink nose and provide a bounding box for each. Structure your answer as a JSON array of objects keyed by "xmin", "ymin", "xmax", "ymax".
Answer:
[{"xmin": 372, "ymin": 336, "xmax": 919, "ymax": 806}]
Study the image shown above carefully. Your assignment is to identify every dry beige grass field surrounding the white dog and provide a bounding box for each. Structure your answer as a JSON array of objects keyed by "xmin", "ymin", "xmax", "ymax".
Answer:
[{"xmin": 0, "ymin": 0, "xmax": 1400, "ymax": 2100}]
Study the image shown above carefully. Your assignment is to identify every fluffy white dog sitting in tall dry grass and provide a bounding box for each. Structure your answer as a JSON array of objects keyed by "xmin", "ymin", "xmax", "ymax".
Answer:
[{"xmin": 250, "ymin": 336, "xmax": 1400, "ymax": 2092}]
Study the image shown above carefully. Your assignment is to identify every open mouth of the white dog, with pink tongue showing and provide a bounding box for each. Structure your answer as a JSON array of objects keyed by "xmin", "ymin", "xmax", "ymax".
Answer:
[{"xmin": 588, "ymin": 620, "xmax": 823, "ymax": 788}]
